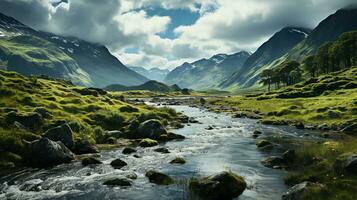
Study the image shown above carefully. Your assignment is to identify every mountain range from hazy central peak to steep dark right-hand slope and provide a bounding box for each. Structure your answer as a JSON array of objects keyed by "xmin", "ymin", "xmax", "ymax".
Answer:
[{"xmin": 164, "ymin": 8, "xmax": 357, "ymax": 91}]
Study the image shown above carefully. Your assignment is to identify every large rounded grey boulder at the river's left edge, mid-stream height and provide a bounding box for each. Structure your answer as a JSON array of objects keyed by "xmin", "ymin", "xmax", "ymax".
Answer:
[{"xmin": 136, "ymin": 119, "xmax": 167, "ymax": 140}]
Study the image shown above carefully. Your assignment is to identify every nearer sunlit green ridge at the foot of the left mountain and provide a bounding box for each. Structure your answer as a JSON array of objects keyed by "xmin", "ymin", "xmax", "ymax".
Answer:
[{"xmin": 0, "ymin": 35, "xmax": 89, "ymax": 84}]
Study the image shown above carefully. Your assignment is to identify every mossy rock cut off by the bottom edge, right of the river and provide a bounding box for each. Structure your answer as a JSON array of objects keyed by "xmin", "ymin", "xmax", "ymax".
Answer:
[{"xmin": 282, "ymin": 181, "xmax": 323, "ymax": 200}]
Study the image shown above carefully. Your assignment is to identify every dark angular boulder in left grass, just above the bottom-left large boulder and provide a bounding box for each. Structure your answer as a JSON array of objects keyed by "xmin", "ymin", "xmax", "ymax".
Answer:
[{"xmin": 43, "ymin": 124, "xmax": 73, "ymax": 149}]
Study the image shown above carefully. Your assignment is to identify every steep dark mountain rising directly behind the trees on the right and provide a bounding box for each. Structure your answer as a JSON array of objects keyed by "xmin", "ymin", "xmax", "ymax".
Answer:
[{"xmin": 220, "ymin": 8, "xmax": 357, "ymax": 90}]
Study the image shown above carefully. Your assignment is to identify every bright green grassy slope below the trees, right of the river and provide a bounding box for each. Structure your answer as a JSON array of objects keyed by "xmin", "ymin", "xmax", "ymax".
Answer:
[{"xmin": 210, "ymin": 67, "xmax": 357, "ymax": 127}]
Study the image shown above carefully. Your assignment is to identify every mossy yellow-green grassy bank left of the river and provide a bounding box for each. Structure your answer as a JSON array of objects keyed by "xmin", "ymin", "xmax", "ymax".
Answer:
[{"xmin": 0, "ymin": 70, "xmax": 179, "ymax": 172}]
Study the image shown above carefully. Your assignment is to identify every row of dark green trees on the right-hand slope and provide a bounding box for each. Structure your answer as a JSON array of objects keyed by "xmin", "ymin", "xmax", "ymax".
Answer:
[{"xmin": 260, "ymin": 31, "xmax": 357, "ymax": 91}]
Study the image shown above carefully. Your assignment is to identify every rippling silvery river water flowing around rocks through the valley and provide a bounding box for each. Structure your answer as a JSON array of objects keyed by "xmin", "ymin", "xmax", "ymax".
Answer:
[{"xmin": 0, "ymin": 106, "xmax": 322, "ymax": 200}]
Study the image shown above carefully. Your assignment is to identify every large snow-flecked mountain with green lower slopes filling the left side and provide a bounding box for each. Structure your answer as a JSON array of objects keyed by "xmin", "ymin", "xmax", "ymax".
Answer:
[{"xmin": 0, "ymin": 14, "xmax": 148, "ymax": 87}]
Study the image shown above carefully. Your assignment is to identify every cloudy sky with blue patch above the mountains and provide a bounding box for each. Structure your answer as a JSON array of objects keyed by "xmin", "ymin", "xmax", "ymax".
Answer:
[{"xmin": 0, "ymin": 0, "xmax": 356, "ymax": 69}]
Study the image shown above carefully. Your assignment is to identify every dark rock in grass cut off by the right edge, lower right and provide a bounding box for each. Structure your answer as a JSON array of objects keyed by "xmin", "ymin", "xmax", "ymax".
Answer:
[{"xmin": 333, "ymin": 153, "xmax": 357, "ymax": 175}]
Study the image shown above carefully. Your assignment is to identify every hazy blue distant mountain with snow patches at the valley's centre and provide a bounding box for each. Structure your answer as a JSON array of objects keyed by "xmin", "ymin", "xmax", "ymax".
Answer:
[{"xmin": 164, "ymin": 51, "xmax": 250, "ymax": 90}]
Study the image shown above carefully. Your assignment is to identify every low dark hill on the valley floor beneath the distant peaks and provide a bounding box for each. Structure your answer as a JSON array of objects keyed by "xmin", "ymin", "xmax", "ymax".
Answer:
[{"xmin": 104, "ymin": 80, "xmax": 181, "ymax": 92}]
